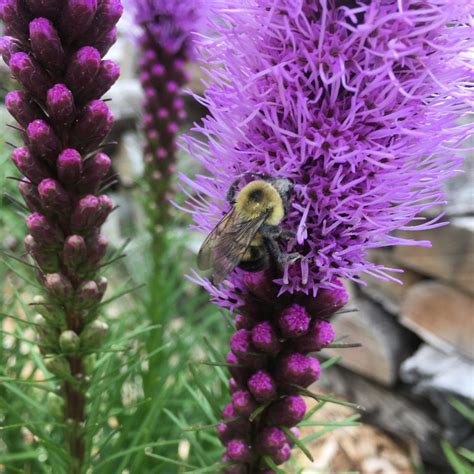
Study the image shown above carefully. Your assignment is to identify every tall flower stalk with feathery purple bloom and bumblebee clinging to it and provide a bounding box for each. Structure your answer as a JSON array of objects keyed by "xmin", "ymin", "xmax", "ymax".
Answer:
[{"xmin": 183, "ymin": 0, "xmax": 472, "ymax": 473}]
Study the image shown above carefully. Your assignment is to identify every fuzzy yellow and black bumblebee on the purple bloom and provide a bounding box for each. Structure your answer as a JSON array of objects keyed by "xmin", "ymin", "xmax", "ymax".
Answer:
[{"xmin": 198, "ymin": 173, "xmax": 294, "ymax": 283}]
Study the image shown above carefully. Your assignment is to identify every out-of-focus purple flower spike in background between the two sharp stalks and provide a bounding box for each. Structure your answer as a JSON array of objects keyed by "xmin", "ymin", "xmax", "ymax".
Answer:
[{"xmin": 129, "ymin": 0, "xmax": 202, "ymax": 243}]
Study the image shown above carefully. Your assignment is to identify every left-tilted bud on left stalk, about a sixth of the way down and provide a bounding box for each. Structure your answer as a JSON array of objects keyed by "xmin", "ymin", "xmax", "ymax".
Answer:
[{"xmin": 9, "ymin": 52, "xmax": 51, "ymax": 100}]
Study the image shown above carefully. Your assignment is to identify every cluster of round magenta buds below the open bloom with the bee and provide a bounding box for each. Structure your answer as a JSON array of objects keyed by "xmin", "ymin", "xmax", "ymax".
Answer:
[{"xmin": 217, "ymin": 272, "xmax": 348, "ymax": 474}]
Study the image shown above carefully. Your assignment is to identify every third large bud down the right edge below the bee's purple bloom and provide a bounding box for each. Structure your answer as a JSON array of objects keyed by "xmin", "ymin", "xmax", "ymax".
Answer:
[{"xmin": 276, "ymin": 352, "xmax": 321, "ymax": 387}]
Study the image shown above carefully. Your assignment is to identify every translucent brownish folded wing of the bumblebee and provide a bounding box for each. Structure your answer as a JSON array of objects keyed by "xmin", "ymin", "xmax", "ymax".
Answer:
[{"xmin": 198, "ymin": 209, "xmax": 267, "ymax": 283}]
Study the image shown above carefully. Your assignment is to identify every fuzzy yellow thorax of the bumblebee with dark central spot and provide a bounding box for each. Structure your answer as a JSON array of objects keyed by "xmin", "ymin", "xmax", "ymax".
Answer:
[{"xmin": 235, "ymin": 180, "xmax": 285, "ymax": 225}]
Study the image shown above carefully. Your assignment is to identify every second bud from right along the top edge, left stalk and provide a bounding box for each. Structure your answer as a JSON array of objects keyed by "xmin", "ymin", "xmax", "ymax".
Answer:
[{"xmin": 59, "ymin": 0, "xmax": 97, "ymax": 42}]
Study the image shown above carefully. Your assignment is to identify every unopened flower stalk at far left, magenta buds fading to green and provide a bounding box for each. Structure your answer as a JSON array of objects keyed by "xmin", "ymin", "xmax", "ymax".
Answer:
[{"xmin": 0, "ymin": 0, "xmax": 122, "ymax": 473}]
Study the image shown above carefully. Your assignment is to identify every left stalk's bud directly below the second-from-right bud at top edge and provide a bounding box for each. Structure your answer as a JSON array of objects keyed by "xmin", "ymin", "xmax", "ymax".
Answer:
[{"xmin": 65, "ymin": 46, "xmax": 101, "ymax": 93}]
